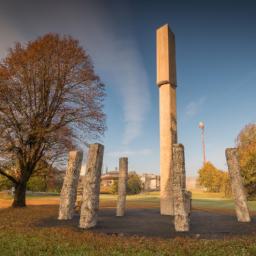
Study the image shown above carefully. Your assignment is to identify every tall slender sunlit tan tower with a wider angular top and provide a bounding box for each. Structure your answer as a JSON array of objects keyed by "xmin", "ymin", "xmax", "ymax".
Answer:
[{"xmin": 156, "ymin": 24, "xmax": 177, "ymax": 215}]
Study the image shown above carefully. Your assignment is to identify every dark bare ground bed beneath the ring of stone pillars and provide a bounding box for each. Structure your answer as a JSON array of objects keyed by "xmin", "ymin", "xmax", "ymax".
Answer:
[{"xmin": 37, "ymin": 208, "xmax": 256, "ymax": 239}]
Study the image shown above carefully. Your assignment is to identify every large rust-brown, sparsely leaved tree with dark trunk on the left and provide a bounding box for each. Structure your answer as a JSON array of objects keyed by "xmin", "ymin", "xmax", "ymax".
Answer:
[{"xmin": 0, "ymin": 34, "xmax": 105, "ymax": 207}]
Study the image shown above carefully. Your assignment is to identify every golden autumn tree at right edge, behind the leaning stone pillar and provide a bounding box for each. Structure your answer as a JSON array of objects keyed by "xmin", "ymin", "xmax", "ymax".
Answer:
[{"xmin": 236, "ymin": 124, "xmax": 256, "ymax": 196}]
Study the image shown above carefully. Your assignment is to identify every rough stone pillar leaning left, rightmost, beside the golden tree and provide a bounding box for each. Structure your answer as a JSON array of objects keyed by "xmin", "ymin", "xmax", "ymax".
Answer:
[{"xmin": 226, "ymin": 148, "xmax": 251, "ymax": 222}]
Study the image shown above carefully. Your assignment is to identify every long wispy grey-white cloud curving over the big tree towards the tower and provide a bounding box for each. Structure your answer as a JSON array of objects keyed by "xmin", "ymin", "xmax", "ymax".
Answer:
[{"xmin": 0, "ymin": 0, "xmax": 150, "ymax": 145}]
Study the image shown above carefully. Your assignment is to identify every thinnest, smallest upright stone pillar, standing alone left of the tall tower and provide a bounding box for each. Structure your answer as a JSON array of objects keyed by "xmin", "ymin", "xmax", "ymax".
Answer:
[{"xmin": 116, "ymin": 157, "xmax": 128, "ymax": 216}]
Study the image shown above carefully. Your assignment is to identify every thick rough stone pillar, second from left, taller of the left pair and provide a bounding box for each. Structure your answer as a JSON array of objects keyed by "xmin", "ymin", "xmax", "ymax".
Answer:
[{"xmin": 79, "ymin": 144, "xmax": 104, "ymax": 229}]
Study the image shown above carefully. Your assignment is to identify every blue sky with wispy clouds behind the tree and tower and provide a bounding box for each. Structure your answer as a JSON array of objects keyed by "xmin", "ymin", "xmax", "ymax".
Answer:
[{"xmin": 0, "ymin": 0, "xmax": 256, "ymax": 176}]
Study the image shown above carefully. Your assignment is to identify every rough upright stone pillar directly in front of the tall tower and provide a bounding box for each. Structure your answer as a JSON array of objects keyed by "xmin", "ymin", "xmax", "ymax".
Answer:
[{"xmin": 173, "ymin": 144, "xmax": 191, "ymax": 232}]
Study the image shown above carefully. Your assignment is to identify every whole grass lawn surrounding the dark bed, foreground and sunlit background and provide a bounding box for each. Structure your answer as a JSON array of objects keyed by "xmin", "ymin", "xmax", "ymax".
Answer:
[{"xmin": 0, "ymin": 191, "xmax": 256, "ymax": 256}]
